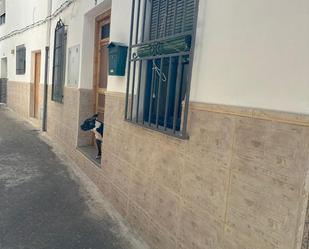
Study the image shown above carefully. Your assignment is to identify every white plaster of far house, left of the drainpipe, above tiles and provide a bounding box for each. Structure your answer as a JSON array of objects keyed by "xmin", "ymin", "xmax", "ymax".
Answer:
[{"xmin": 0, "ymin": 0, "xmax": 47, "ymax": 82}]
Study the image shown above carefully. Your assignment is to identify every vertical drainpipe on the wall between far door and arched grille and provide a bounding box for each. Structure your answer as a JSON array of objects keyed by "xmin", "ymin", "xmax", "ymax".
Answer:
[{"xmin": 42, "ymin": 0, "xmax": 53, "ymax": 131}]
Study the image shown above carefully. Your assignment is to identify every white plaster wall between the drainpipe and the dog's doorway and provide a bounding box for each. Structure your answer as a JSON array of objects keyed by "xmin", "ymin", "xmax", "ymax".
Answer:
[{"xmin": 49, "ymin": 0, "xmax": 111, "ymax": 89}]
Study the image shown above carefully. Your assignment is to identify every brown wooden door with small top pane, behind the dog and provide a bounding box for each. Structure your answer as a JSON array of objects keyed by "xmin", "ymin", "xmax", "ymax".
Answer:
[{"xmin": 93, "ymin": 10, "xmax": 111, "ymax": 122}]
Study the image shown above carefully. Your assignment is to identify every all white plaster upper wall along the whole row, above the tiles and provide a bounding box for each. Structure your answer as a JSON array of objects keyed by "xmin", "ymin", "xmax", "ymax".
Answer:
[{"xmin": 0, "ymin": 0, "xmax": 309, "ymax": 114}]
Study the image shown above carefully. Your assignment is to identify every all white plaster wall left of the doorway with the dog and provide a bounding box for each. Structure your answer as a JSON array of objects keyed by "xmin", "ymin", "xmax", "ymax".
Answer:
[{"xmin": 0, "ymin": 0, "xmax": 111, "ymax": 89}]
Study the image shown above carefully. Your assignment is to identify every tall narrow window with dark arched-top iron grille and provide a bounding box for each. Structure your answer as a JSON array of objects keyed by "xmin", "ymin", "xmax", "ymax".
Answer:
[{"xmin": 52, "ymin": 20, "xmax": 67, "ymax": 102}]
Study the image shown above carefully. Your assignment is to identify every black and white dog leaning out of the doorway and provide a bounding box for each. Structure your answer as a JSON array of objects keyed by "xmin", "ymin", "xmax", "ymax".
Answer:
[{"xmin": 80, "ymin": 114, "xmax": 104, "ymax": 159}]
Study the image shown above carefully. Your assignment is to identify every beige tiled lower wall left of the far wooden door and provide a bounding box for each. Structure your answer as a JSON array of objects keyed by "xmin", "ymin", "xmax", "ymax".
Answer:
[{"xmin": 7, "ymin": 81, "xmax": 30, "ymax": 118}]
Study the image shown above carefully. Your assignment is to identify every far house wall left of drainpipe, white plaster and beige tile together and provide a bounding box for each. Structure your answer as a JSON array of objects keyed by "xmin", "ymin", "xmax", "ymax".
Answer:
[{"xmin": 0, "ymin": 0, "xmax": 47, "ymax": 118}]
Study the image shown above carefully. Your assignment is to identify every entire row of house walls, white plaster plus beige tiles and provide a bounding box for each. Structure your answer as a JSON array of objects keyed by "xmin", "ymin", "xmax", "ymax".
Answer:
[{"xmin": 0, "ymin": 0, "xmax": 309, "ymax": 249}]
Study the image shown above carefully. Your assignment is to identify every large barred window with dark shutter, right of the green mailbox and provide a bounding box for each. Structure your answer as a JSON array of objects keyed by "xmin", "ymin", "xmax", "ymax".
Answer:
[{"xmin": 125, "ymin": 0, "xmax": 198, "ymax": 138}]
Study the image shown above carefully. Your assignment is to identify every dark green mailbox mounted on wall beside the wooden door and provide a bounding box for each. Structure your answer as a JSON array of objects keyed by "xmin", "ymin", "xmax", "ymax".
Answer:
[{"xmin": 108, "ymin": 42, "xmax": 128, "ymax": 76}]
